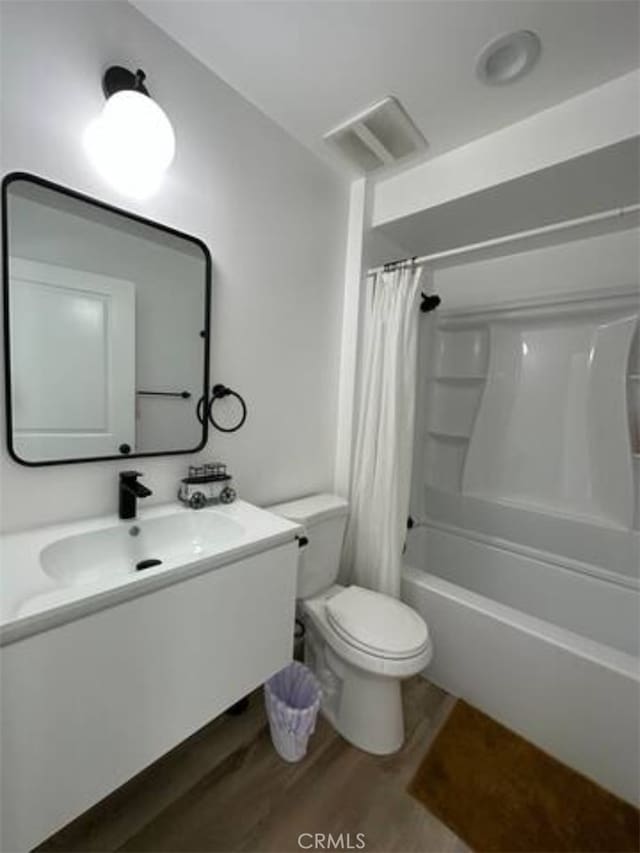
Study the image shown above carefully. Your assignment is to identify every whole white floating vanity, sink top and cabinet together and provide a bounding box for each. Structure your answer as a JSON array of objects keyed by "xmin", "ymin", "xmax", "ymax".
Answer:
[{"xmin": 0, "ymin": 501, "xmax": 301, "ymax": 850}]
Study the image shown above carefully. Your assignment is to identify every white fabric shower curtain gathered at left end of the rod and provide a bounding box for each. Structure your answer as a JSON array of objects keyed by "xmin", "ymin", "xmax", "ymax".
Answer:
[{"xmin": 344, "ymin": 267, "xmax": 421, "ymax": 598}]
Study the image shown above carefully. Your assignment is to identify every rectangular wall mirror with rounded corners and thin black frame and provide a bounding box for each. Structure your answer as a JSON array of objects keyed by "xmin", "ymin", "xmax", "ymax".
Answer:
[{"xmin": 2, "ymin": 173, "xmax": 211, "ymax": 465}]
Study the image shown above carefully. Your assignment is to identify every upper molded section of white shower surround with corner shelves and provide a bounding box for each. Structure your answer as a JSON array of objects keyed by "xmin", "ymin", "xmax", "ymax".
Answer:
[{"xmin": 424, "ymin": 294, "xmax": 640, "ymax": 529}]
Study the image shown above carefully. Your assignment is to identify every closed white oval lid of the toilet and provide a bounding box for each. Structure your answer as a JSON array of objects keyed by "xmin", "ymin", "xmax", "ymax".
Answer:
[{"xmin": 326, "ymin": 586, "xmax": 429, "ymax": 658}]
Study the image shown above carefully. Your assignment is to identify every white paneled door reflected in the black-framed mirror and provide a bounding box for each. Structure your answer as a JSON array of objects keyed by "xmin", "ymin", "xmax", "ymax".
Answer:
[{"xmin": 10, "ymin": 257, "xmax": 135, "ymax": 461}]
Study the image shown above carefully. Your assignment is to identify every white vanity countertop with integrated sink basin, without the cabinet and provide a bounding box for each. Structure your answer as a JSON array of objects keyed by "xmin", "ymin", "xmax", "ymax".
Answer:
[{"xmin": 0, "ymin": 501, "xmax": 302, "ymax": 645}]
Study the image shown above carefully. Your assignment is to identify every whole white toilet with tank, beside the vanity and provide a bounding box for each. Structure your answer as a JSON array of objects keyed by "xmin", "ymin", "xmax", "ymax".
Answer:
[{"xmin": 269, "ymin": 495, "xmax": 432, "ymax": 755}]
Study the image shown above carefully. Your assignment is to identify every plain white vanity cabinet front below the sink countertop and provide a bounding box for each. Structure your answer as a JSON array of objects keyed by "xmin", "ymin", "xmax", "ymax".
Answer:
[{"xmin": 0, "ymin": 528, "xmax": 298, "ymax": 853}]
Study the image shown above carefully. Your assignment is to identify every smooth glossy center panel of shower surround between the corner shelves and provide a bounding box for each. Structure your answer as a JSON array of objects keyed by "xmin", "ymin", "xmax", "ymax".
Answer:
[{"xmin": 462, "ymin": 302, "xmax": 639, "ymax": 530}]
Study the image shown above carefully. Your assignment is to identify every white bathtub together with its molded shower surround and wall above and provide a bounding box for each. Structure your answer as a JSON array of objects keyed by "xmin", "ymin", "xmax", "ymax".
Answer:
[{"xmin": 380, "ymin": 215, "xmax": 640, "ymax": 802}]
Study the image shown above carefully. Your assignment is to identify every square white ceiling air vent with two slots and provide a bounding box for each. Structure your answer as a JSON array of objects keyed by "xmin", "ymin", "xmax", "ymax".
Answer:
[{"xmin": 324, "ymin": 96, "xmax": 428, "ymax": 172}]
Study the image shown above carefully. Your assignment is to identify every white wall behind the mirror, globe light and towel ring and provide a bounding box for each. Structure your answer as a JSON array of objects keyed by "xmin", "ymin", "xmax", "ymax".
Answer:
[{"xmin": 0, "ymin": 0, "xmax": 347, "ymax": 530}]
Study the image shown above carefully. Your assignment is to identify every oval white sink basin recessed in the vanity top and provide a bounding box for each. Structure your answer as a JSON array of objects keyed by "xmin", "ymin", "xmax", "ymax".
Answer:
[{"xmin": 40, "ymin": 509, "xmax": 245, "ymax": 585}]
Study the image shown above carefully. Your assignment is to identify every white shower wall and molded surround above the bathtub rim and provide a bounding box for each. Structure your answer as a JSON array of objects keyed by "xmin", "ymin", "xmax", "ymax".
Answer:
[{"xmin": 412, "ymin": 233, "xmax": 640, "ymax": 572}]
